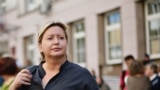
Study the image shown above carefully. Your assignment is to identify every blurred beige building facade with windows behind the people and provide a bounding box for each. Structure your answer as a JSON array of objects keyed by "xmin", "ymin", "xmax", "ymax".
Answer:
[{"xmin": 0, "ymin": 0, "xmax": 160, "ymax": 88}]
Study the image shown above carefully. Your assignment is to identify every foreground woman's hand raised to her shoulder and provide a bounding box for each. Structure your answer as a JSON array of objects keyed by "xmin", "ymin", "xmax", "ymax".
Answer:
[{"xmin": 9, "ymin": 69, "xmax": 32, "ymax": 90}]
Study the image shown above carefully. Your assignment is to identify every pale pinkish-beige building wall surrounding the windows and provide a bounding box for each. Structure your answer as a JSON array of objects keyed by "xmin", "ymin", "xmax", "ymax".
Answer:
[{"xmin": 0, "ymin": 0, "xmax": 144, "ymax": 75}]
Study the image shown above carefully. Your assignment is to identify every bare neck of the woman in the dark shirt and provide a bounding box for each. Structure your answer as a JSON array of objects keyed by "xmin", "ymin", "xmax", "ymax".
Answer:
[{"xmin": 43, "ymin": 56, "xmax": 66, "ymax": 71}]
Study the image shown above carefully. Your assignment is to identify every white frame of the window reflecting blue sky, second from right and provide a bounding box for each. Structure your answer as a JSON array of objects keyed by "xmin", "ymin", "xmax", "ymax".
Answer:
[{"xmin": 104, "ymin": 9, "xmax": 123, "ymax": 65}]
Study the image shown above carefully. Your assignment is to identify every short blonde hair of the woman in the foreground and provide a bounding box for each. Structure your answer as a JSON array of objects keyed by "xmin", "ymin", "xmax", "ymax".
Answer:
[{"xmin": 38, "ymin": 22, "xmax": 68, "ymax": 59}]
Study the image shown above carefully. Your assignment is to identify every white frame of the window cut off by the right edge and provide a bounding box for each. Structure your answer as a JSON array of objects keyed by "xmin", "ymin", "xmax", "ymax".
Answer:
[{"xmin": 144, "ymin": 1, "xmax": 160, "ymax": 59}]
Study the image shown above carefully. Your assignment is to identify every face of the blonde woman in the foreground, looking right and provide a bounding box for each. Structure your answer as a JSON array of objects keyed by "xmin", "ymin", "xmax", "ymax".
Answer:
[{"xmin": 39, "ymin": 26, "xmax": 67, "ymax": 57}]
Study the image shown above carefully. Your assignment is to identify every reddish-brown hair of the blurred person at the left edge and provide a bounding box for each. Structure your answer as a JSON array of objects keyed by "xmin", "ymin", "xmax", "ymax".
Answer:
[{"xmin": 0, "ymin": 57, "xmax": 18, "ymax": 75}]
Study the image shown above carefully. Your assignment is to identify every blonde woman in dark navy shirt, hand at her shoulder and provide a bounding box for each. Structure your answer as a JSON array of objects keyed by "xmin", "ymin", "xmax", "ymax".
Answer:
[{"xmin": 10, "ymin": 22, "xmax": 98, "ymax": 90}]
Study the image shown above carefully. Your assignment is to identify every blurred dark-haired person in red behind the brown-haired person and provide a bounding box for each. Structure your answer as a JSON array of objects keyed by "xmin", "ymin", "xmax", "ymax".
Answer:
[{"xmin": 120, "ymin": 55, "xmax": 135, "ymax": 90}]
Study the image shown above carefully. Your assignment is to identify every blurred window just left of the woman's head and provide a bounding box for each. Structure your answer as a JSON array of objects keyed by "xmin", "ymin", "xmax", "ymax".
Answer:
[{"xmin": 24, "ymin": 35, "xmax": 34, "ymax": 63}]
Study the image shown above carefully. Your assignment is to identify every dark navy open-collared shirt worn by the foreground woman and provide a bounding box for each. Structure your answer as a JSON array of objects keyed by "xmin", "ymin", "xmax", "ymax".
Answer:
[{"xmin": 20, "ymin": 61, "xmax": 98, "ymax": 90}]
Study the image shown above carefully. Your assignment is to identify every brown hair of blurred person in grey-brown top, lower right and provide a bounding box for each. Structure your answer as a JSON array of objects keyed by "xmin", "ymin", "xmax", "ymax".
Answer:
[{"xmin": 129, "ymin": 61, "xmax": 144, "ymax": 76}]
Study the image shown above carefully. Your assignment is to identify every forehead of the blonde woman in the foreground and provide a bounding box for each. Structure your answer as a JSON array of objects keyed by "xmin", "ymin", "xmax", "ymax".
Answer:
[{"xmin": 44, "ymin": 26, "xmax": 64, "ymax": 36}]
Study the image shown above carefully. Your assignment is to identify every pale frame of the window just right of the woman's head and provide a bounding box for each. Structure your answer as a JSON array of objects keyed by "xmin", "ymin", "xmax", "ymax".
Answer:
[{"xmin": 72, "ymin": 19, "xmax": 86, "ymax": 67}]
